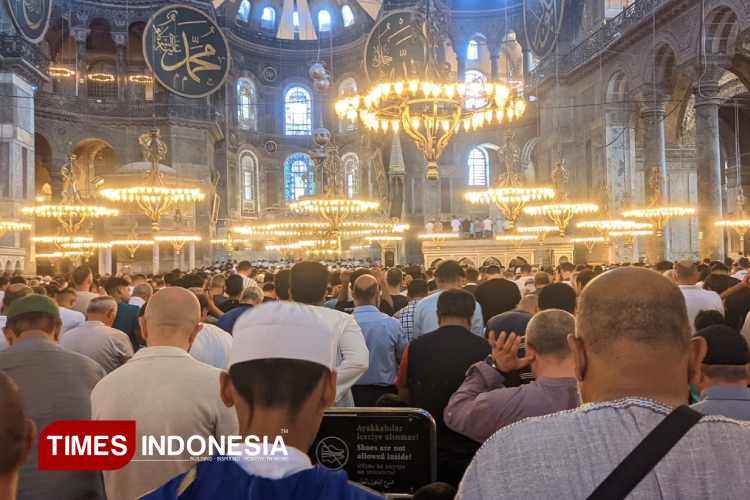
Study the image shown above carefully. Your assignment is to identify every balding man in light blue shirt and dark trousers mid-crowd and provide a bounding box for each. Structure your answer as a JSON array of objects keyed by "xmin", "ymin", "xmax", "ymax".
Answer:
[{"xmin": 352, "ymin": 274, "xmax": 406, "ymax": 406}]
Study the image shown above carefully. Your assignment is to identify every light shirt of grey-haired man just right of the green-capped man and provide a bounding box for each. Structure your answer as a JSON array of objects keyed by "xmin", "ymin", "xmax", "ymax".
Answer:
[{"xmin": 60, "ymin": 321, "xmax": 133, "ymax": 373}]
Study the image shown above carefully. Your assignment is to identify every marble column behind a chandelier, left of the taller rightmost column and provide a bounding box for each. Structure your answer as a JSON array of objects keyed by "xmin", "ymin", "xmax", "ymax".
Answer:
[{"xmin": 641, "ymin": 91, "xmax": 670, "ymax": 264}]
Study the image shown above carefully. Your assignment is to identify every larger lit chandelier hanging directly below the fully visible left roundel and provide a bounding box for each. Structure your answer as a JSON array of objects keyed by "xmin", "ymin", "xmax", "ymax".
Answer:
[{"xmin": 101, "ymin": 129, "xmax": 205, "ymax": 231}]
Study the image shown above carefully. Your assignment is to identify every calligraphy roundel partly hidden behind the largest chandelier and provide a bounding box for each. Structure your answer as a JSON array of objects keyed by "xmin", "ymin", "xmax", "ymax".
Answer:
[{"xmin": 365, "ymin": 10, "xmax": 424, "ymax": 83}]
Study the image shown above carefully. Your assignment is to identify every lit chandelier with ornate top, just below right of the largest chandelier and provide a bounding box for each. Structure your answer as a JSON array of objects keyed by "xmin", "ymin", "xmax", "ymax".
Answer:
[{"xmin": 466, "ymin": 133, "xmax": 555, "ymax": 230}]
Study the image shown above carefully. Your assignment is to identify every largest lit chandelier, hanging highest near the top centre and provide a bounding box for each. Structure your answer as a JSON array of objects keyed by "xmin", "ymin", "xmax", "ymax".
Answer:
[{"xmin": 335, "ymin": 0, "xmax": 526, "ymax": 180}]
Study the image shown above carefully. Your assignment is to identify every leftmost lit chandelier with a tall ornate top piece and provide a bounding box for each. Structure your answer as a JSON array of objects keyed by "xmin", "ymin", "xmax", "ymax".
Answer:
[{"xmin": 21, "ymin": 155, "xmax": 119, "ymax": 235}]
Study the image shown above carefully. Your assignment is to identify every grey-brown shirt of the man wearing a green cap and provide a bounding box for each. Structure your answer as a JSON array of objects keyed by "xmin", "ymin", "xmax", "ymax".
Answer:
[{"xmin": 0, "ymin": 337, "xmax": 105, "ymax": 500}]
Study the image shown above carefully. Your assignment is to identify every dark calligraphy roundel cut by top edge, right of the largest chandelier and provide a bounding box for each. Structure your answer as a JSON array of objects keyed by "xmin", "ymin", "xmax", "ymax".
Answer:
[{"xmin": 523, "ymin": 0, "xmax": 565, "ymax": 59}]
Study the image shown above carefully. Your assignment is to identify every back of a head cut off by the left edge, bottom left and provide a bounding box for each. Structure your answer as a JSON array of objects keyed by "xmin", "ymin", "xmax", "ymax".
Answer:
[{"xmin": 0, "ymin": 370, "xmax": 34, "ymax": 478}]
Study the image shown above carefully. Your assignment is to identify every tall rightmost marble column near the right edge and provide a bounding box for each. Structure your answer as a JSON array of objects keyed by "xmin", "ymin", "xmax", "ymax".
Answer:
[{"xmin": 693, "ymin": 77, "xmax": 724, "ymax": 260}]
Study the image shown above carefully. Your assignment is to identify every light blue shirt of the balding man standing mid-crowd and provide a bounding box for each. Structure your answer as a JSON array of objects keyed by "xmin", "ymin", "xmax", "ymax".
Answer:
[{"xmin": 352, "ymin": 306, "xmax": 407, "ymax": 385}]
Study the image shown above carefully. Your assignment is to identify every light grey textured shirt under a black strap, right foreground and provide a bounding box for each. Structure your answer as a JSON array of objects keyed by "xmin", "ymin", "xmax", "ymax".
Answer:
[{"xmin": 456, "ymin": 398, "xmax": 750, "ymax": 500}]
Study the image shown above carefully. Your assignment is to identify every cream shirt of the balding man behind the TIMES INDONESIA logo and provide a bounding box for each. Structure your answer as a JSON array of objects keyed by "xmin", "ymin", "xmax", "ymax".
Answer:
[{"xmin": 91, "ymin": 346, "xmax": 239, "ymax": 500}]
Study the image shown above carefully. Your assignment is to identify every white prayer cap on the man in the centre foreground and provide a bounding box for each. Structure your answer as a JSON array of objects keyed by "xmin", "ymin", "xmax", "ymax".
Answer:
[{"xmin": 229, "ymin": 302, "xmax": 334, "ymax": 370}]
